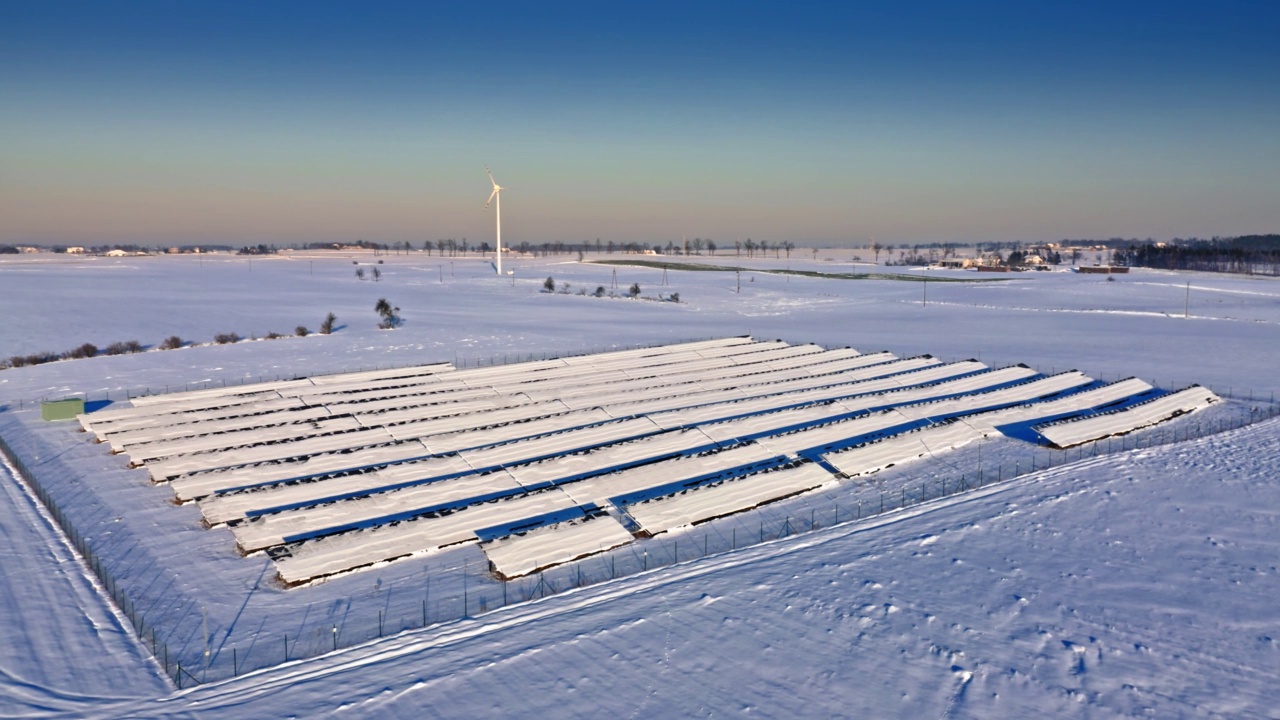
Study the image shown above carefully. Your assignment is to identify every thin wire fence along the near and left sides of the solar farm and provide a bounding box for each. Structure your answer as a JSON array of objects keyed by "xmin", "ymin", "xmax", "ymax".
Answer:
[{"xmin": 0, "ymin": 392, "xmax": 1280, "ymax": 688}]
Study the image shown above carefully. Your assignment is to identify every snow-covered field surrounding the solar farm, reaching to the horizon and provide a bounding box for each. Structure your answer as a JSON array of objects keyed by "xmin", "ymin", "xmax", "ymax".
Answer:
[{"xmin": 0, "ymin": 254, "xmax": 1280, "ymax": 717}]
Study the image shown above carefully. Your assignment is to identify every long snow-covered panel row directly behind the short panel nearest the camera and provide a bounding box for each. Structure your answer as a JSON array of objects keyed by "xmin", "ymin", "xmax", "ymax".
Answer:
[{"xmin": 275, "ymin": 489, "xmax": 586, "ymax": 584}]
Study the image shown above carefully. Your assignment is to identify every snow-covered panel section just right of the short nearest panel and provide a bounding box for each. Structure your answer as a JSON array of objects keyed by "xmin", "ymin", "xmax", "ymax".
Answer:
[{"xmin": 627, "ymin": 462, "xmax": 833, "ymax": 534}]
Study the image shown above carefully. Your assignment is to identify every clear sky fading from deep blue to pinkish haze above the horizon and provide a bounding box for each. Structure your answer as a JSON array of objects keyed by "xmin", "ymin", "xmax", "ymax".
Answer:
[{"xmin": 0, "ymin": 0, "xmax": 1280, "ymax": 245}]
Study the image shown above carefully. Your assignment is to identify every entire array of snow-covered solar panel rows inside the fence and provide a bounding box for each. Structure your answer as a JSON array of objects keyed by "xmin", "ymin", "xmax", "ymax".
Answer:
[{"xmin": 81, "ymin": 337, "xmax": 1217, "ymax": 584}]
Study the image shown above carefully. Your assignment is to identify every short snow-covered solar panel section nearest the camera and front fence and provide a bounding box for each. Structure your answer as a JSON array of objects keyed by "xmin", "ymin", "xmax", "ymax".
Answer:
[{"xmin": 480, "ymin": 515, "xmax": 635, "ymax": 579}]
